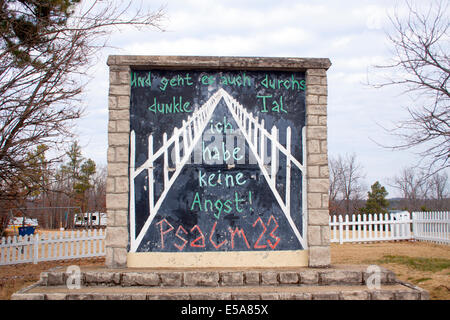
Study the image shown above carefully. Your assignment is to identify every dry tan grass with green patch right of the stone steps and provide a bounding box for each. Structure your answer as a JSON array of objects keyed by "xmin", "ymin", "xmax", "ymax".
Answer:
[{"xmin": 331, "ymin": 241, "xmax": 450, "ymax": 300}]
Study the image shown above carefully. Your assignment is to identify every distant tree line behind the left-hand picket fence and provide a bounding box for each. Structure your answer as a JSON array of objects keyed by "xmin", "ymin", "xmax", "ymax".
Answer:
[{"xmin": 0, "ymin": 141, "xmax": 106, "ymax": 228}]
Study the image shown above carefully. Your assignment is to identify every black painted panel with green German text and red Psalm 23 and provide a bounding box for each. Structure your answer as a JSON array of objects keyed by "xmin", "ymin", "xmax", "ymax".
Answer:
[{"xmin": 130, "ymin": 70, "xmax": 305, "ymax": 252}]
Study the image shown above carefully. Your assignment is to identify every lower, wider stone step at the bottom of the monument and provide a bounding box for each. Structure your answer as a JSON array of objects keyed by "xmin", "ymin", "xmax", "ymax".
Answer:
[{"xmin": 11, "ymin": 283, "xmax": 429, "ymax": 300}]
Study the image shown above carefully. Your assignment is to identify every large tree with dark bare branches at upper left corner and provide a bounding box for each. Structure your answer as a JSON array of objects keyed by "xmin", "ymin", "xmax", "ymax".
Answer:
[{"xmin": 0, "ymin": 0, "xmax": 163, "ymax": 199}]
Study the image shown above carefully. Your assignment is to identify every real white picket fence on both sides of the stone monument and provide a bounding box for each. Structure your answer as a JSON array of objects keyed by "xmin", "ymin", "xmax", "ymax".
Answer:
[{"xmin": 0, "ymin": 212, "xmax": 450, "ymax": 265}]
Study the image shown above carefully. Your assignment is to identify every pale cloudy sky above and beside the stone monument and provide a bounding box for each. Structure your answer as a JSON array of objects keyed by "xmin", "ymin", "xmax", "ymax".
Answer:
[{"xmin": 77, "ymin": 0, "xmax": 446, "ymax": 197}]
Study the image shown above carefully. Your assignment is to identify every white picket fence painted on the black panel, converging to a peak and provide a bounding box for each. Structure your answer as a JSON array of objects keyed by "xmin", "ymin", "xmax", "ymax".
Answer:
[{"xmin": 130, "ymin": 89, "xmax": 307, "ymax": 252}]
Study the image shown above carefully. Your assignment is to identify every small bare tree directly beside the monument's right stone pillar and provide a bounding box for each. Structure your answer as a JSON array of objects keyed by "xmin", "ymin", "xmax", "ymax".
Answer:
[{"xmin": 330, "ymin": 154, "xmax": 365, "ymax": 214}]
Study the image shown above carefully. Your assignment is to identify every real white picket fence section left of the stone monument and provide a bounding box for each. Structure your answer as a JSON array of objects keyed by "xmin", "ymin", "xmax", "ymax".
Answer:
[{"xmin": 0, "ymin": 229, "xmax": 106, "ymax": 265}]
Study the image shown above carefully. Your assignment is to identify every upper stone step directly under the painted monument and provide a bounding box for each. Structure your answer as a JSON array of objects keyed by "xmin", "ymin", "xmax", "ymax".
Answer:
[{"xmin": 40, "ymin": 265, "xmax": 397, "ymax": 287}]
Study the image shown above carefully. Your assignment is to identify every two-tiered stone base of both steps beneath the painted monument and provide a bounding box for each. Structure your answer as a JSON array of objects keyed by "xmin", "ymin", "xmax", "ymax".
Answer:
[{"xmin": 11, "ymin": 266, "xmax": 429, "ymax": 300}]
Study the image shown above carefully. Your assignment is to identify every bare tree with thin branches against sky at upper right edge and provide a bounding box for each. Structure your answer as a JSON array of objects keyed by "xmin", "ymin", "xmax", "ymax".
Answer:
[{"xmin": 377, "ymin": 0, "xmax": 450, "ymax": 172}]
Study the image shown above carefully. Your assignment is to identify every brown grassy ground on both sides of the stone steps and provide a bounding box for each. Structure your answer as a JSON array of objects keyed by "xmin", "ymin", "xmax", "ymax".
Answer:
[{"xmin": 0, "ymin": 241, "xmax": 450, "ymax": 300}]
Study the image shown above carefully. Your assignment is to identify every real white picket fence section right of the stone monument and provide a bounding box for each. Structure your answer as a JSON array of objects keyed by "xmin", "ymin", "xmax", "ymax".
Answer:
[{"xmin": 330, "ymin": 212, "xmax": 450, "ymax": 244}]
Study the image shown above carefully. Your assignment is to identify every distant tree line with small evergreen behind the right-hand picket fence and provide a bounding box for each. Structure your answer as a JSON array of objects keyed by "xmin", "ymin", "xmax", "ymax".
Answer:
[{"xmin": 329, "ymin": 154, "xmax": 450, "ymax": 215}]
